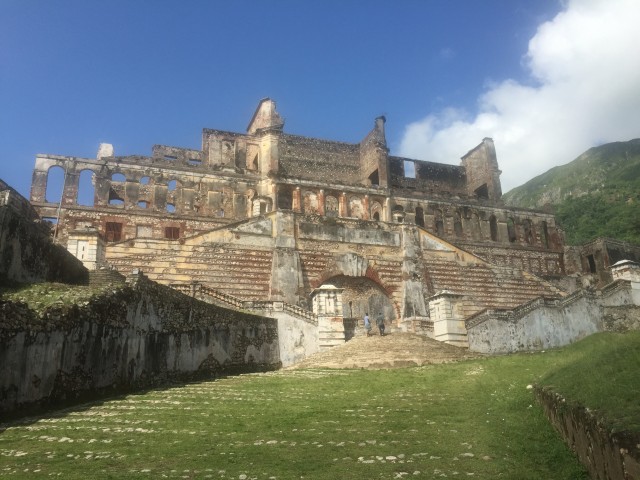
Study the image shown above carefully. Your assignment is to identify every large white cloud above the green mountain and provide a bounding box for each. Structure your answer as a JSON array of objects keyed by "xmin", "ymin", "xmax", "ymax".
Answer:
[{"xmin": 400, "ymin": 0, "xmax": 640, "ymax": 191}]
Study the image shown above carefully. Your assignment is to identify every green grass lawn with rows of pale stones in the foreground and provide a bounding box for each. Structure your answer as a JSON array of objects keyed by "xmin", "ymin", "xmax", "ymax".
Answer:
[{"xmin": 0, "ymin": 334, "xmax": 640, "ymax": 480}]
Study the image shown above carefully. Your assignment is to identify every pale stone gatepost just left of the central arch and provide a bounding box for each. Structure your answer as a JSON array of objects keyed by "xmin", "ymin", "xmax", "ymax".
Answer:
[{"xmin": 311, "ymin": 285, "xmax": 346, "ymax": 351}]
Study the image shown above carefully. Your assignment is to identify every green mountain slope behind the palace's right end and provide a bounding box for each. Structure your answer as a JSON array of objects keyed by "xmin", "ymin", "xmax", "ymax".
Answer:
[{"xmin": 503, "ymin": 138, "xmax": 640, "ymax": 245}]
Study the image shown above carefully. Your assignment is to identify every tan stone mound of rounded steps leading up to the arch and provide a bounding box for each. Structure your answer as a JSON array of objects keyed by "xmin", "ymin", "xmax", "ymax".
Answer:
[{"xmin": 287, "ymin": 332, "xmax": 482, "ymax": 370}]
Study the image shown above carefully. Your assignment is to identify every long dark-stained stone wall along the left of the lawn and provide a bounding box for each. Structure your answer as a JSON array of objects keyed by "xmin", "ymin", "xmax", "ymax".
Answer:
[{"xmin": 0, "ymin": 275, "xmax": 281, "ymax": 414}]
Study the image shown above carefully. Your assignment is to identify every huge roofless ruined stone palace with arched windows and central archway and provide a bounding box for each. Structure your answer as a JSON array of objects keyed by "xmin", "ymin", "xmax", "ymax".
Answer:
[{"xmin": 31, "ymin": 99, "xmax": 565, "ymax": 347}]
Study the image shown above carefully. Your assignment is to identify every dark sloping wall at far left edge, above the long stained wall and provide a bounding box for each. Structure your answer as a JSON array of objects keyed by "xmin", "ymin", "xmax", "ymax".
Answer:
[{"xmin": 0, "ymin": 205, "xmax": 88, "ymax": 284}]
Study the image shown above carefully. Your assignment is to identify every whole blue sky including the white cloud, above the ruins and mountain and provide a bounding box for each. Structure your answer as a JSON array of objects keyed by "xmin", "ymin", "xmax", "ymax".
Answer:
[{"xmin": 0, "ymin": 0, "xmax": 640, "ymax": 196}]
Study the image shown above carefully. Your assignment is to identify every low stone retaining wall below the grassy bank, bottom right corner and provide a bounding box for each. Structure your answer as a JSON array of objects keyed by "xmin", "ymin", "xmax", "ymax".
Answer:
[{"xmin": 535, "ymin": 387, "xmax": 640, "ymax": 480}]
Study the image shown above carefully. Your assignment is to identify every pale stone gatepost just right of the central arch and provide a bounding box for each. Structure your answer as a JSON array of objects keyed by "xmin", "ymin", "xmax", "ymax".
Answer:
[{"xmin": 429, "ymin": 290, "xmax": 469, "ymax": 347}]
